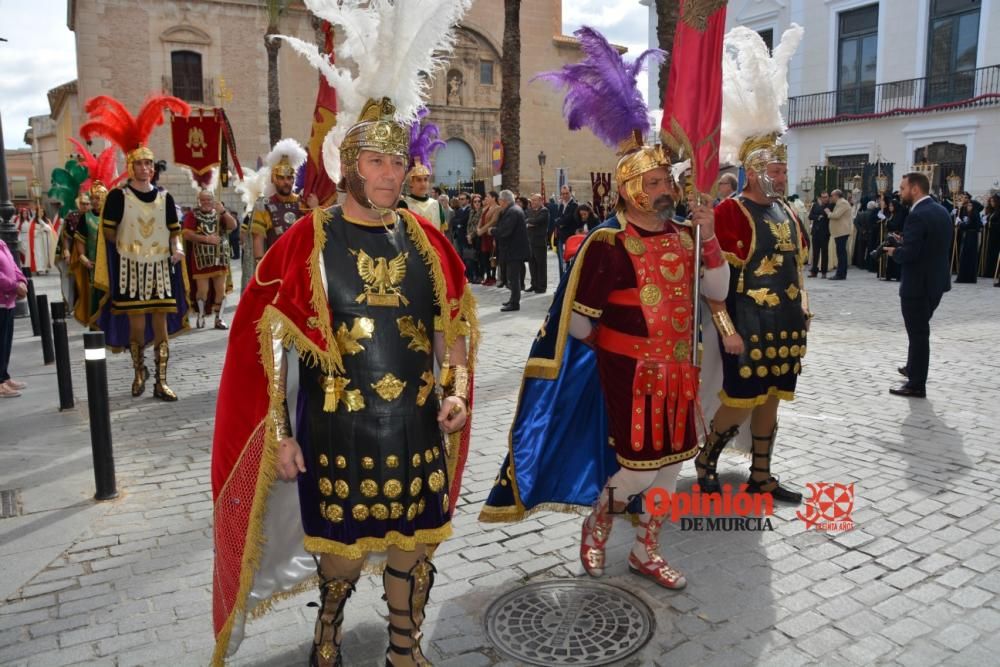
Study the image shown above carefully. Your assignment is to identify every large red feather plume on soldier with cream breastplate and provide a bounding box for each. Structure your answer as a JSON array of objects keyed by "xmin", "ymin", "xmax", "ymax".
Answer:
[{"xmin": 80, "ymin": 95, "xmax": 191, "ymax": 155}]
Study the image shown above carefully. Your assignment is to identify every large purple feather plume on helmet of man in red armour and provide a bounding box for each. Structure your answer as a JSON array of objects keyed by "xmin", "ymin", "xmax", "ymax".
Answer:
[{"xmin": 532, "ymin": 26, "xmax": 666, "ymax": 148}]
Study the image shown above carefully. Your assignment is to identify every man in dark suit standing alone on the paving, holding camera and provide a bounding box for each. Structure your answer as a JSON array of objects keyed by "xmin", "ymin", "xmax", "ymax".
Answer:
[{"xmin": 886, "ymin": 172, "xmax": 952, "ymax": 398}]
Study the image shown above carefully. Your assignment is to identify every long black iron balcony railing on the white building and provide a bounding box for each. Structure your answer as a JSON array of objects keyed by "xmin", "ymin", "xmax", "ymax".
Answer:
[{"xmin": 788, "ymin": 65, "xmax": 1000, "ymax": 127}]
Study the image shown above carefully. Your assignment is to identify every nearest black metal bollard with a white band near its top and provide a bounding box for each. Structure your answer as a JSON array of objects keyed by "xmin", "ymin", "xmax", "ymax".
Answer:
[{"xmin": 83, "ymin": 331, "xmax": 118, "ymax": 500}]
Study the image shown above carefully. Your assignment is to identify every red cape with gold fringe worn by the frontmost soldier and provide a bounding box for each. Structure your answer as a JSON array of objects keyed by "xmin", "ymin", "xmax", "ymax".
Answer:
[{"xmin": 212, "ymin": 210, "xmax": 478, "ymax": 664}]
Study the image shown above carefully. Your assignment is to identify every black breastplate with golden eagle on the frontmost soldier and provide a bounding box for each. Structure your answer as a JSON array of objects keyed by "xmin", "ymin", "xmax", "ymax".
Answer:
[{"xmin": 303, "ymin": 207, "xmax": 436, "ymax": 416}]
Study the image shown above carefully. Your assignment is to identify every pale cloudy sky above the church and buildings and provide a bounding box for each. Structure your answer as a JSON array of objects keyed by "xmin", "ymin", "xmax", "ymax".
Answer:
[{"xmin": 0, "ymin": 0, "xmax": 648, "ymax": 148}]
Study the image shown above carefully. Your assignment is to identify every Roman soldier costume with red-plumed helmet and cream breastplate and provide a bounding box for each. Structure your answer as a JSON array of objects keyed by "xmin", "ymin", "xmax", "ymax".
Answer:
[{"xmin": 80, "ymin": 95, "xmax": 191, "ymax": 401}]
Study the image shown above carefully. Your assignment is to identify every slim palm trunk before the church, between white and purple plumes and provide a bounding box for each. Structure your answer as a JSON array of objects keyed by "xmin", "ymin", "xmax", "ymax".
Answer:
[{"xmin": 500, "ymin": 0, "xmax": 521, "ymax": 192}]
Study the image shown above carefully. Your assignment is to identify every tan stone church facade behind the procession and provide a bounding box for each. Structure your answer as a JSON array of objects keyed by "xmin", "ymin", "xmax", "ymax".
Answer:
[{"xmin": 45, "ymin": 0, "xmax": 616, "ymax": 209}]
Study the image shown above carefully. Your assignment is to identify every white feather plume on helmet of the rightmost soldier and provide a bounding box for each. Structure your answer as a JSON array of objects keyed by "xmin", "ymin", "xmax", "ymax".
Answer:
[{"xmin": 720, "ymin": 23, "xmax": 804, "ymax": 164}]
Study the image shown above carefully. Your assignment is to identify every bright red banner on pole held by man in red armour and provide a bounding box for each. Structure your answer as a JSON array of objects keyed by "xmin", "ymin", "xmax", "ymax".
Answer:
[{"xmin": 660, "ymin": 0, "xmax": 726, "ymax": 196}]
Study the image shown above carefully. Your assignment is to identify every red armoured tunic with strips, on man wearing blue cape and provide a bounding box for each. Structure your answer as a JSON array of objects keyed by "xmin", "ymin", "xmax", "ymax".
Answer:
[{"xmin": 573, "ymin": 224, "xmax": 698, "ymax": 469}]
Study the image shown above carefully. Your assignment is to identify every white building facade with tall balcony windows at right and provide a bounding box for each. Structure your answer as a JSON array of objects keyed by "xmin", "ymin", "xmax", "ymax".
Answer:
[{"xmin": 644, "ymin": 0, "xmax": 1000, "ymax": 197}]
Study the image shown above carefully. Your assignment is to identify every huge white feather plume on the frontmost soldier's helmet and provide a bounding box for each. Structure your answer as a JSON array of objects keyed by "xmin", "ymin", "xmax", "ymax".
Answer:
[{"xmin": 275, "ymin": 0, "xmax": 472, "ymax": 181}]
